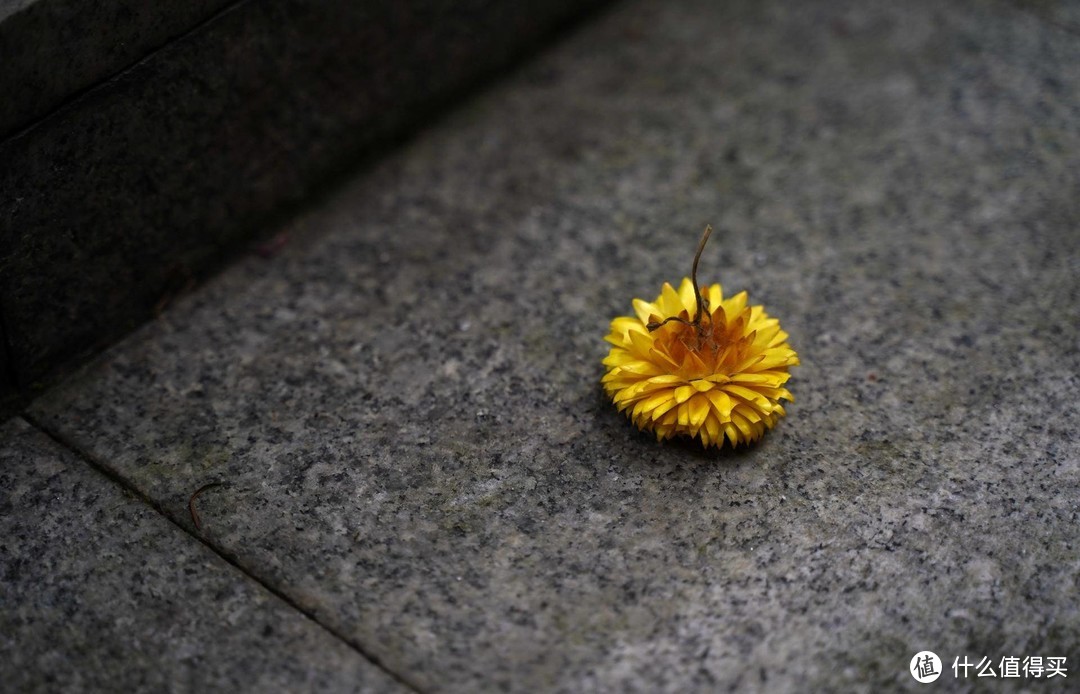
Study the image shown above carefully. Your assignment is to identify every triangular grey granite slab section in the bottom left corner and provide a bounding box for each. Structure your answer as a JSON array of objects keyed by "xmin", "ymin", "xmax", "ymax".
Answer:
[{"xmin": 0, "ymin": 420, "xmax": 409, "ymax": 692}]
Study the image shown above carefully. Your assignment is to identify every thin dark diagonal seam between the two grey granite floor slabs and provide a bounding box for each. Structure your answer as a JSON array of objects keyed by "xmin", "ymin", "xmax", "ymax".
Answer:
[{"xmin": 18, "ymin": 412, "xmax": 424, "ymax": 694}]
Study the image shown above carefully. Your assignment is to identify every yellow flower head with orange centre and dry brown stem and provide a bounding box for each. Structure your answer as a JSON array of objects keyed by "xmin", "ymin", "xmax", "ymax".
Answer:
[{"xmin": 602, "ymin": 228, "xmax": 799, "ymax": 448}]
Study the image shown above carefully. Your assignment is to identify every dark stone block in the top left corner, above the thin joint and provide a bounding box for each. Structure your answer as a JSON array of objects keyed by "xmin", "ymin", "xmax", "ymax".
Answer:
[{"xmin": 0, "ymin": 0, "xmax": 228, "ymax": 139}]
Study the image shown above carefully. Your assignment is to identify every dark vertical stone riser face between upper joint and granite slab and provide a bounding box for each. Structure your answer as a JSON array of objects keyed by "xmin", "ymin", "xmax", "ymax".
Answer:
[{"xmin": 0, "ymin": 0, "xmax": 598, "ymax": 397}]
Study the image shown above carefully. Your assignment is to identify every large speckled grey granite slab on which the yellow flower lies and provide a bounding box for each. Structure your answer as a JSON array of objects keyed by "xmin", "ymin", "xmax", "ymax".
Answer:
[{"xmin": 25, "ymin": 0, "xmax": 1080, "ymax": 692}]
